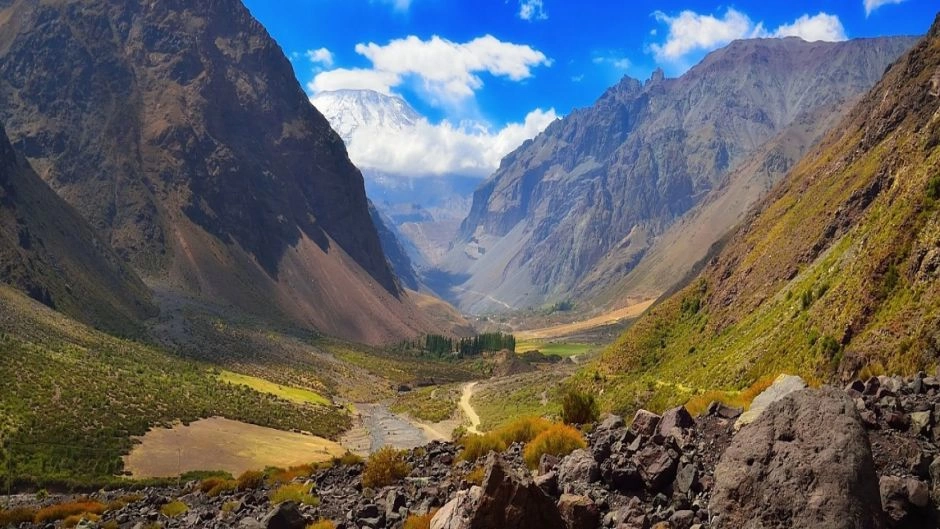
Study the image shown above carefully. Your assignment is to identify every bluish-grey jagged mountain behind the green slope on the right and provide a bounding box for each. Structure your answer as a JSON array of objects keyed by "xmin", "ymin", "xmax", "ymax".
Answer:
[{"xmin": 442, "ymin": 38, "xmax": 914, "ymax": 312}]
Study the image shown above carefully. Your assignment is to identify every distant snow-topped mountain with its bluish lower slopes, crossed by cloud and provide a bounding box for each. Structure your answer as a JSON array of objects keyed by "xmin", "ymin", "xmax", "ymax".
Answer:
[{"xmin": 310, "ymin": 90, "xmax": 480, "ymax": 269}]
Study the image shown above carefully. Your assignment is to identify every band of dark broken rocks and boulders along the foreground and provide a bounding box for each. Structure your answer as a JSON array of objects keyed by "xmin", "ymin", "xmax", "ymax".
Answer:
[{"xmin": 14, "ymin": 374, "xmax": 940, "ymax": 529}]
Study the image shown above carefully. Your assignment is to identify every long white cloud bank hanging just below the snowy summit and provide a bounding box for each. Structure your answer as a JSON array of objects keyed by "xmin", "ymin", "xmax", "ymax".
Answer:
[{"xmin": 346, "ymin": 109, "xmax": 558, "ymax": 178}]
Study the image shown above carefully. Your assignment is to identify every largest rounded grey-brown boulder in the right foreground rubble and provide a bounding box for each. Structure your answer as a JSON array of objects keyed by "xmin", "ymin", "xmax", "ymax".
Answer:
[{"xmin": 710, "ymin": 388, "xmax": 884, "ymax": 529}]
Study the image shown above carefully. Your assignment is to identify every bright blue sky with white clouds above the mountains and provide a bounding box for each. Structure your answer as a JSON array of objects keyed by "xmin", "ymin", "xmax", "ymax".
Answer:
[{"xmin": 245, "ymin": 0, "xmax": 938, "ymax": 177}]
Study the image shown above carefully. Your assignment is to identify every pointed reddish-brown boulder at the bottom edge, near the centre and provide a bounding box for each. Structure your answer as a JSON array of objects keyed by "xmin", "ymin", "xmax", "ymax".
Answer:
[{"xmin": 431, "ymin": 454, "xmax": 564, "ymax": 529}]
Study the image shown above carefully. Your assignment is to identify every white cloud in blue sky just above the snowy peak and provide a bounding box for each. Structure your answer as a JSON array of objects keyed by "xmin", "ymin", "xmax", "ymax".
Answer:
[{"xmin": 307, "ymin": 35, "xmax": 551, "ymax": 103}]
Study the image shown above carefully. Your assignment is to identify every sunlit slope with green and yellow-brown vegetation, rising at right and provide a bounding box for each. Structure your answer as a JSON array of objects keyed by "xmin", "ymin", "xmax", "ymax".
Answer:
[{"xmin": 585, "ymin": 16, "xmax": 940, "ymax": 416}]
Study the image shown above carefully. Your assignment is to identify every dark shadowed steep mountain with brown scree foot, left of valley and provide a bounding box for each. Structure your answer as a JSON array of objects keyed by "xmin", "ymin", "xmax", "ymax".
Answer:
[{"xmin": 0, "ymin": 0, "xmax": 429, "ymax": 343}]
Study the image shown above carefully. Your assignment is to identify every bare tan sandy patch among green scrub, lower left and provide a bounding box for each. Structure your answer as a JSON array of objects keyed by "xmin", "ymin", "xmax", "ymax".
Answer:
[{"xmin": 124, "ymin": 417, "xmax": 346, "ymax": 478}]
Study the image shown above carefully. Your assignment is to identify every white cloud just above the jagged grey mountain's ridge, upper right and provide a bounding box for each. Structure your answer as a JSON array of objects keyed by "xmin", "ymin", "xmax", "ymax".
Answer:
[{"xmin": 650, "ymin": 8, "xmax": 848, "ymax": 64}]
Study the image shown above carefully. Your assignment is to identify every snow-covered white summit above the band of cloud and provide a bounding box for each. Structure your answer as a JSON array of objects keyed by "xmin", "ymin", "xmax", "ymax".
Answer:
[{"xmin": 310, "ymin": 90, "xmax": 421, "ymax": 144}]
